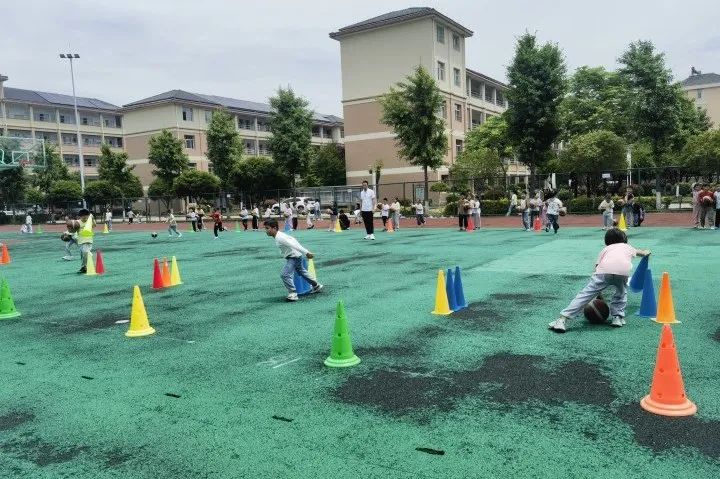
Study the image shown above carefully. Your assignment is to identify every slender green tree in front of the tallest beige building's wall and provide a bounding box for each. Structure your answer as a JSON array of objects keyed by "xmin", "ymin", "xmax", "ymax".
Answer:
[{"xmin": 380, "ymin": 66, "xmax": 448, "ymax": 205}]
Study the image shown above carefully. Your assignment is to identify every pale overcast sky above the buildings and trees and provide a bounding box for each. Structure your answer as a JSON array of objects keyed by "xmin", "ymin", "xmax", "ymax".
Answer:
[{"xmin": 0, "ymin": 0, "xmax": 720, "ymax": 116}]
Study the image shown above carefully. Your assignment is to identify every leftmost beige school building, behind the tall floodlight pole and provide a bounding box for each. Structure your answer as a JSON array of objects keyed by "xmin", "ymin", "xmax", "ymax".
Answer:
[{"xmin": 0, "ymin": 87, "xmax": 125, "ymax": 179}]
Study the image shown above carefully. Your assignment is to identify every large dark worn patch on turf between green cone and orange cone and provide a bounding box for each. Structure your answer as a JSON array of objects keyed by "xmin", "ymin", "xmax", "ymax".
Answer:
[{"xmin": 332, "ymin": 353, "xmax": 615, "ymax": 417}]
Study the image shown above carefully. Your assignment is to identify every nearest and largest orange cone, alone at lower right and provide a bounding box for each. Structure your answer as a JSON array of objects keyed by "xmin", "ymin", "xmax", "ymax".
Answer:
[{"xmin": 640, "ymin": 324, "xmax": 697, "ymax": 416}]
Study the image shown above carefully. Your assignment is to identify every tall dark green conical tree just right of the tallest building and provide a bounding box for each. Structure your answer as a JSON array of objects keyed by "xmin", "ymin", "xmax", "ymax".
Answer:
[{"xmin": 505, "ymin": 33, "xmax": 566, "ymax": 187}]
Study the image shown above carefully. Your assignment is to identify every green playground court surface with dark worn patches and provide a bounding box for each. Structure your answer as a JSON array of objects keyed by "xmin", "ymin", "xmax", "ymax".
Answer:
[{"xmin": 0, "ymin": 226, "xmax": 720, "ymax": 479}]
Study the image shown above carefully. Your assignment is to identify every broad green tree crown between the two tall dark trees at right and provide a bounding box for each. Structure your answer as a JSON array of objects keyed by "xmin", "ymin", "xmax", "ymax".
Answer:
[{"xmin": 559, "ymin": 66, "xmax": 627, "ymax": 140}]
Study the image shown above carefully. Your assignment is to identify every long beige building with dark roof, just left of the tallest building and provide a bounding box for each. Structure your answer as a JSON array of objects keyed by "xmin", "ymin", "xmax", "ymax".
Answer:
[{"xmin": 122, "ymin": 90, "xmax": 345, "ymax": 187}]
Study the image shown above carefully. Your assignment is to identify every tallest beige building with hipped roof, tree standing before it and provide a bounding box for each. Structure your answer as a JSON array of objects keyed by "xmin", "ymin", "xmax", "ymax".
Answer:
[{"xmin": 330, "ymin": 8, "xmax": 526, "ymax": 194}]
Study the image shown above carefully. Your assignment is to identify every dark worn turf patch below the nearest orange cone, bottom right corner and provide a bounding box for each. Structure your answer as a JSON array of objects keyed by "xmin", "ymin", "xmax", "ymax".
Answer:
[{"xmin": 617, "ymin": 404, "xmax": 720, "ymax": 459}]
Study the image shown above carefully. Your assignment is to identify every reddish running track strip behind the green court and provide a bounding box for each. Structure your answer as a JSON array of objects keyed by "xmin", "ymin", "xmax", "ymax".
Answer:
[{"xmin": 0, "ymin": 211, "xmax": 693, "ymax": 233}]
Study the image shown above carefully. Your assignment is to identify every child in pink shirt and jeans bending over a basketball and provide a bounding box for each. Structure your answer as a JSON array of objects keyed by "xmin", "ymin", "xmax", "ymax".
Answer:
[{"xmin": 549, "ymin": 228, "xmax": 650, "ymax": 333}]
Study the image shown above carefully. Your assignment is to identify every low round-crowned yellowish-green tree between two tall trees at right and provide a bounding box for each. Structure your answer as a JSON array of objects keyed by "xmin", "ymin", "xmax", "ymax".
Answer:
[{"xmin": 559, "ymin": 130, "xmax": 627, "ymax": 196}]
